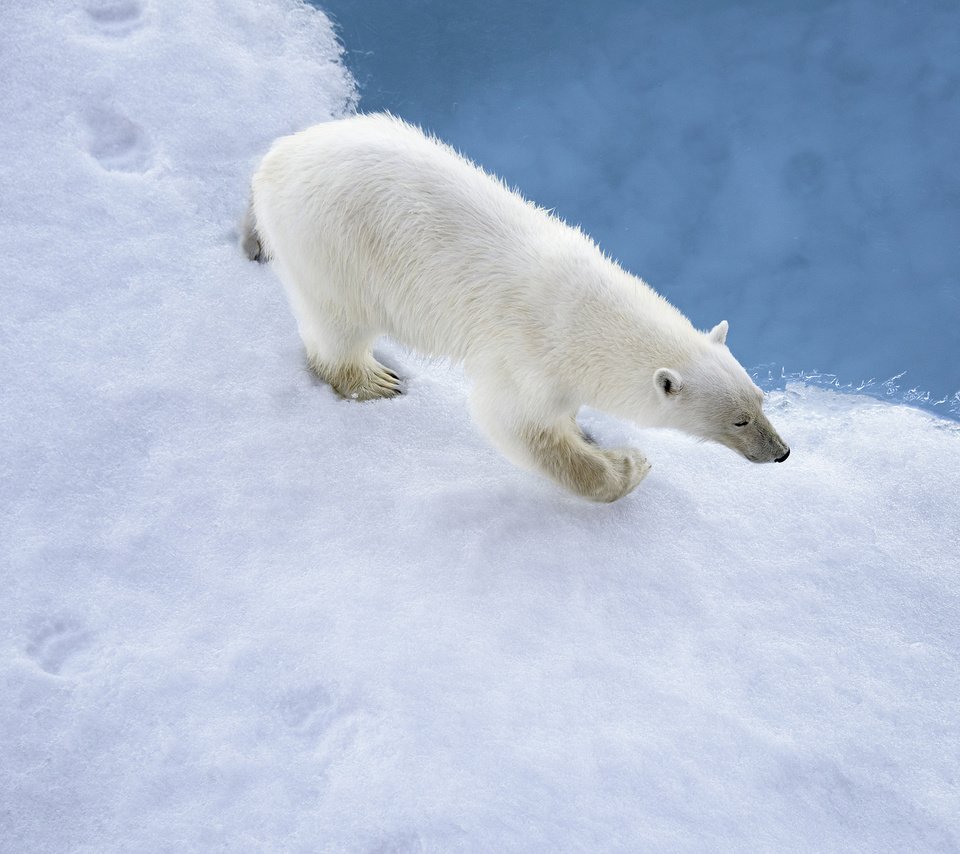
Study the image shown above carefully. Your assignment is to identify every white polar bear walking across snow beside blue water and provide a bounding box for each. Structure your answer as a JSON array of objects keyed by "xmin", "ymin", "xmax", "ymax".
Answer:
[{"xmin": 241, "ymin": 115, "xmax": 790, "ymax": 501}]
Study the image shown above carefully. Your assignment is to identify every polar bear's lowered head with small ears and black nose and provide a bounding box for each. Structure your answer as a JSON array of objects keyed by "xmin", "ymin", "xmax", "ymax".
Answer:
[{"xmin": 653, "ymin": 320, "xmax": 790, "ymax": 463}]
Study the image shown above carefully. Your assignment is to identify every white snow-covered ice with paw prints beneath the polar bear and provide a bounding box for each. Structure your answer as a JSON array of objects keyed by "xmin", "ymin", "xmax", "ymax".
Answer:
[{"xmin": 0, "ymin": 0, "xmax": 960, "ymax": 854}]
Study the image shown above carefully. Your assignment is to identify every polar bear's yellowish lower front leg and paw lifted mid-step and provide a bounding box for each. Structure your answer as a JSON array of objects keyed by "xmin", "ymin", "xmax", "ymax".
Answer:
[{"xmin": 524, "ymin": 419, "xmax": 650, "ymax": 502}]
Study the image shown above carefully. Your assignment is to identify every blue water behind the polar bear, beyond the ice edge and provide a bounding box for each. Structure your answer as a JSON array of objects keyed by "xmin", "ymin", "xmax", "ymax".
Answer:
[{"xmin": 318, "ymin": 0, "xmax": 960, "ymax": 411}]
